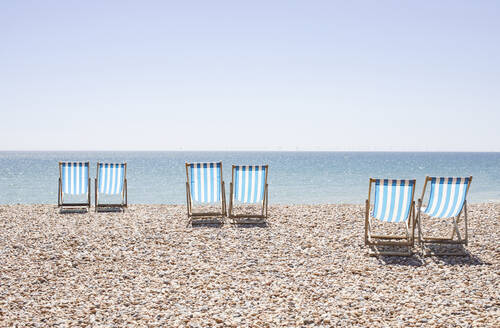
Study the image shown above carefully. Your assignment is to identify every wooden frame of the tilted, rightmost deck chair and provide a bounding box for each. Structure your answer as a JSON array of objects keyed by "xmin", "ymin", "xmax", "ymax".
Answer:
[{"xmin": 417, "ymin": 176, "xmax": 472, "ymax": 256}]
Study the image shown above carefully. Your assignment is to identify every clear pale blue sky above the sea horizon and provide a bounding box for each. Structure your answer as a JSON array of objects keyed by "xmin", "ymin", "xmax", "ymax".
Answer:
[{"xmin": 0, "ymin": 0, "xmax": 500, "ymax": 151}]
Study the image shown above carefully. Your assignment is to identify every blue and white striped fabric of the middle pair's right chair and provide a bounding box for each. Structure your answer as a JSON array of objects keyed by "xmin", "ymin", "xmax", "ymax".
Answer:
[{"xmin": 233, "ymin": 165, "xmax": 266, "ymax": 203}]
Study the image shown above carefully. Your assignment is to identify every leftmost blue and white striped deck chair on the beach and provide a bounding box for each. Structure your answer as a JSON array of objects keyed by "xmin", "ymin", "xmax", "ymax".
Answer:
[{"xmin": 57, "ymin": 162, "xmax": 90, "ymax": 208}]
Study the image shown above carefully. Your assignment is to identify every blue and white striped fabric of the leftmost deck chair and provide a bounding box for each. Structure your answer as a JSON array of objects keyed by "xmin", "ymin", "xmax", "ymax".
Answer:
[{"xmin": 61, "ymin": 162, "xmax": 89, "ymax": 195}]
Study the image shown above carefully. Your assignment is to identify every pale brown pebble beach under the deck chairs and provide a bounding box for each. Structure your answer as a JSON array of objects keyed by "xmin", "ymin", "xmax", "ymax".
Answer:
[{"xmin": 0, "ymin": 203, "xmax": 500, "ymax": 327}]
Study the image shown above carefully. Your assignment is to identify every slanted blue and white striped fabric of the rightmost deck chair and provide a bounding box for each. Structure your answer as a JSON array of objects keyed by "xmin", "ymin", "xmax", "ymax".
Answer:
[{"xmin": 424, "ymin": 178, "xmax": 469, "ymax": 218}]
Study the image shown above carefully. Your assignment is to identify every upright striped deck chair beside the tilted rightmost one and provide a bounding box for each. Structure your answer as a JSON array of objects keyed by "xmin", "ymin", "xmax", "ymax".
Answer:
[{"xmin": 365, "ymin": 179, "xmax": 415, "ymax": 256}]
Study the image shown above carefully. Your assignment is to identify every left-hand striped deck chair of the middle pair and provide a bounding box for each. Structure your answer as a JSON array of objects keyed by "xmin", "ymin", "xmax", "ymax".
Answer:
[{"xmin": 186, "ymin": 162, "xmax": 226, "ymax": 224}]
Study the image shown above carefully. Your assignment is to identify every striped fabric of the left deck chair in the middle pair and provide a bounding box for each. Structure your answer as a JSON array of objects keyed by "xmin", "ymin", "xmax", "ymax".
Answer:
[{"xmin": 189, "ymin": 163, "xmax": 222, "ymax": 203}]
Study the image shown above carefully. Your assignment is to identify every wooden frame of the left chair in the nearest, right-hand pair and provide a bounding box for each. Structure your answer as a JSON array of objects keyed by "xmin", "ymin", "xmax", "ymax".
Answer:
[{"xmin": 365, "ymin": 178, "xmax": 416, "ymax": 256}]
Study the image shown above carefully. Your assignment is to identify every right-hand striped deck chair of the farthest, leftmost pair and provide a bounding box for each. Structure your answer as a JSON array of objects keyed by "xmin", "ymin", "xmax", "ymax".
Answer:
[{"xmin": 94, "ymin": 162, "xmax": 128, "ymax": 212}]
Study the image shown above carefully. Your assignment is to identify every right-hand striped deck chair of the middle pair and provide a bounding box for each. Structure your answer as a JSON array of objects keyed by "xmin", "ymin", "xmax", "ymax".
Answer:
[{"xmin": 228, "ymin": 165, "xmax": 268, "ymax": 223}]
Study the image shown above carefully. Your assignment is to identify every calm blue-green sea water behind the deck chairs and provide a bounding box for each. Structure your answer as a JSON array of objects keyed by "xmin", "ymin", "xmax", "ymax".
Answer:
[{"xmin": 0, "ymin": 151, "xmax": 500, "ymax": 204}]
